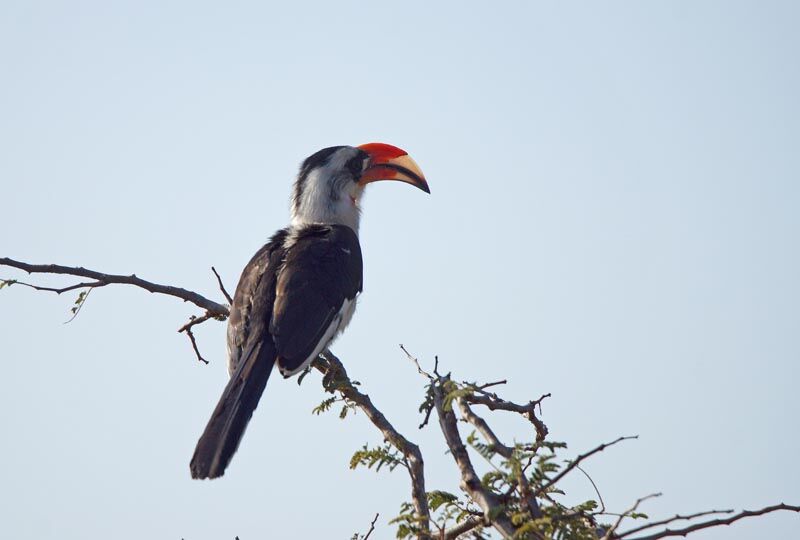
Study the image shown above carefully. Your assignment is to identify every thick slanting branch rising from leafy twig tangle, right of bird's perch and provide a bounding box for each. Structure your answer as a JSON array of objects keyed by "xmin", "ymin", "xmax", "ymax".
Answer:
[{"xmin": 433, "ymin": 377, "xmax": 516, "ymax": 538}]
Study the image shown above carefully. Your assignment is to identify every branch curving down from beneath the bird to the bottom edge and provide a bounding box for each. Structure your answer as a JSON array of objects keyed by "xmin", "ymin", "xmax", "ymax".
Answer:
[{"xmin": 313, "ymin": 349, "xmax": 431, "ymax": 538}]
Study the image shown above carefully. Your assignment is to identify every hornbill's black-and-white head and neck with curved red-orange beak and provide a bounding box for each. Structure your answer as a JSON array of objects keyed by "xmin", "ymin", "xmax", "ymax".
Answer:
[{"xmin": 292, "ymin": 143, "xmax": 430, "ymax": 232}]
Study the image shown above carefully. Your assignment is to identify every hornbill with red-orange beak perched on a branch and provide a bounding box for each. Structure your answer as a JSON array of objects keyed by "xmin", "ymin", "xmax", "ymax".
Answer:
[{"xmin": 190, "ymin": 143, "xmax": 430, "ymax": 478}]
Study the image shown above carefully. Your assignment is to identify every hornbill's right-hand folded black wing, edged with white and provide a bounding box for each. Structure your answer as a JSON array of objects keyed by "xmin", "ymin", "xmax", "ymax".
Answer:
[{"xmin": 269, "ymin": 225, "xmax": 363, "ymax": 374}]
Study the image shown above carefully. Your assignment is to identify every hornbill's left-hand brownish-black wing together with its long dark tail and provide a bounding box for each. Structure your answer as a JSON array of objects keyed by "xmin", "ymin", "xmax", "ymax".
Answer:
[{"xmin": 190, "ymin": 230, "xmax": 287, "ymax": 478}]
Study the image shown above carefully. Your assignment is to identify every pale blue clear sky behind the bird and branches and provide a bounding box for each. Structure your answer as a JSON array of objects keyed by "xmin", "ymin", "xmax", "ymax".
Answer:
[{"xmin": 0, "ymin": 0, "xmax": 800, "ymax": 540}]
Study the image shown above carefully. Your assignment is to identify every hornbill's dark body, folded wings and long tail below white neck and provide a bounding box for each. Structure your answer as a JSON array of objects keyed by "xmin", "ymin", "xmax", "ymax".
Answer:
[{"xmin": 191, "ymin": 225, "xmax": 362, "ymax": 478}]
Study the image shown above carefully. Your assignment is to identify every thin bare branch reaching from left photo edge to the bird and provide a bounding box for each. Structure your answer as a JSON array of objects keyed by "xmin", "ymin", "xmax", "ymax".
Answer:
[{"xmin": 0, "ymin": 257, "xmax": 228, "ymax": 317}]
